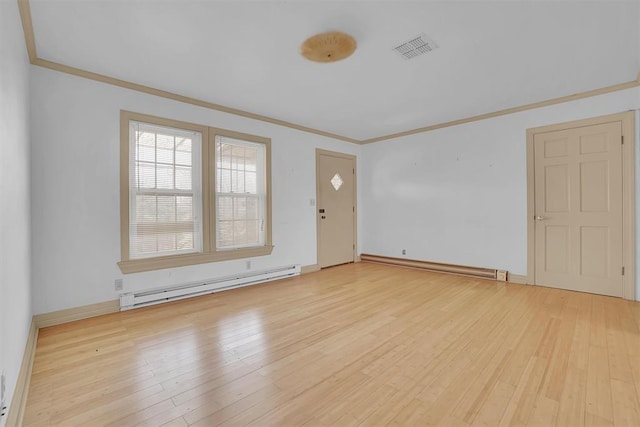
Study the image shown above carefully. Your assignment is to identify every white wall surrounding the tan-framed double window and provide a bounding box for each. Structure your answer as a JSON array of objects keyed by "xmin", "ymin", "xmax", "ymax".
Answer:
[{"xmin": 31, "ymin": 67, "xmax": 360, "ymax": 314}]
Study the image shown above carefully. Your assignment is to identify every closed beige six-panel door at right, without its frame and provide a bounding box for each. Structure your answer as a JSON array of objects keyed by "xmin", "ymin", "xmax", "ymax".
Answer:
[{"xmin": 534, "ymin": 122, "xmax": 622, "ymax": 297}]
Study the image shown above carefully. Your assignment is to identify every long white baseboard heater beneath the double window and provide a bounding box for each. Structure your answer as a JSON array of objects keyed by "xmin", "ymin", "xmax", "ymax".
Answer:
[{"xmin": 120, "ymin": 264, "xmax": 301, "ymax": 311}]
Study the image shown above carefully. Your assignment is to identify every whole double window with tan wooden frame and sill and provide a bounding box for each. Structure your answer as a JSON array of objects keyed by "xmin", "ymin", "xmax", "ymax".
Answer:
[{"xmin": 118, "ymin": 111, "xmax": 273, "ymax": 273}]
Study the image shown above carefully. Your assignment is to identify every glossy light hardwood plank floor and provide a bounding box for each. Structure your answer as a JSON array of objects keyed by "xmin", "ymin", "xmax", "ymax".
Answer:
[{"xmin": 25, "ymin": 263, "xmax": 640, "ymax": 426}]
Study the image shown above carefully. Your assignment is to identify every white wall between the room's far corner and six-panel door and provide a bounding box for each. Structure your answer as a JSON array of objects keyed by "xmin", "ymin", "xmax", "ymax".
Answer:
[{"xmin": 360, "ymin": 88, "xmax": 640, "ymax": 295}]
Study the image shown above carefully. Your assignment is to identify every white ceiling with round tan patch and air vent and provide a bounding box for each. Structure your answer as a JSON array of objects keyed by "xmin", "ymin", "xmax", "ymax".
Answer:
[{"xmin": 30, "ymin": 0, "xmax": 640, "ymax": 140}]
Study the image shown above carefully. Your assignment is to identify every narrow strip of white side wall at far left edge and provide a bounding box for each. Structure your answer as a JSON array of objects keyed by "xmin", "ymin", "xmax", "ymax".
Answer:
[{"xmin": 0, "ymin": 1, "xmax": 31, "ymax": 425}]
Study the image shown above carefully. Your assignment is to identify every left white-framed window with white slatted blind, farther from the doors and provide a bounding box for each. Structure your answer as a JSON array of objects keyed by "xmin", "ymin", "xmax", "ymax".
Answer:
[{"xmin": 129, "ymin": 121, "xmax": 202, "ymax": 258}]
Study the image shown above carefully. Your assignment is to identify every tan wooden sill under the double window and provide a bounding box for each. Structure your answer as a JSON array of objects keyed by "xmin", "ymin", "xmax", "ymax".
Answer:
[{"xmin": 118, "ymin": 245, "xmax": 273, "ymax": 274}]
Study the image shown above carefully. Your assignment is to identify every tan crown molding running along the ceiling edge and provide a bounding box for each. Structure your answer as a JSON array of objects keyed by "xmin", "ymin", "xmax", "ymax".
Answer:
[{"xmin": 17, "ymin": 0, "xmax": 640, "ymax": 144}]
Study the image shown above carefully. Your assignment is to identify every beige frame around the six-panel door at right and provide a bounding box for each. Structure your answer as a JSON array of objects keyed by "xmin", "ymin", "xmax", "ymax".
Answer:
[{"xmin": 527, "ymin": 110, "xmax": 636, "ymax": 300}]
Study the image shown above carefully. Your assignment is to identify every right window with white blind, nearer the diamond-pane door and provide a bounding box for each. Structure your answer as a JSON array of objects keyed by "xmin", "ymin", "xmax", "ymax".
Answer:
[{"xmin": 215, "ymin": 135, "xmax": 267, "ymax": 249}]
